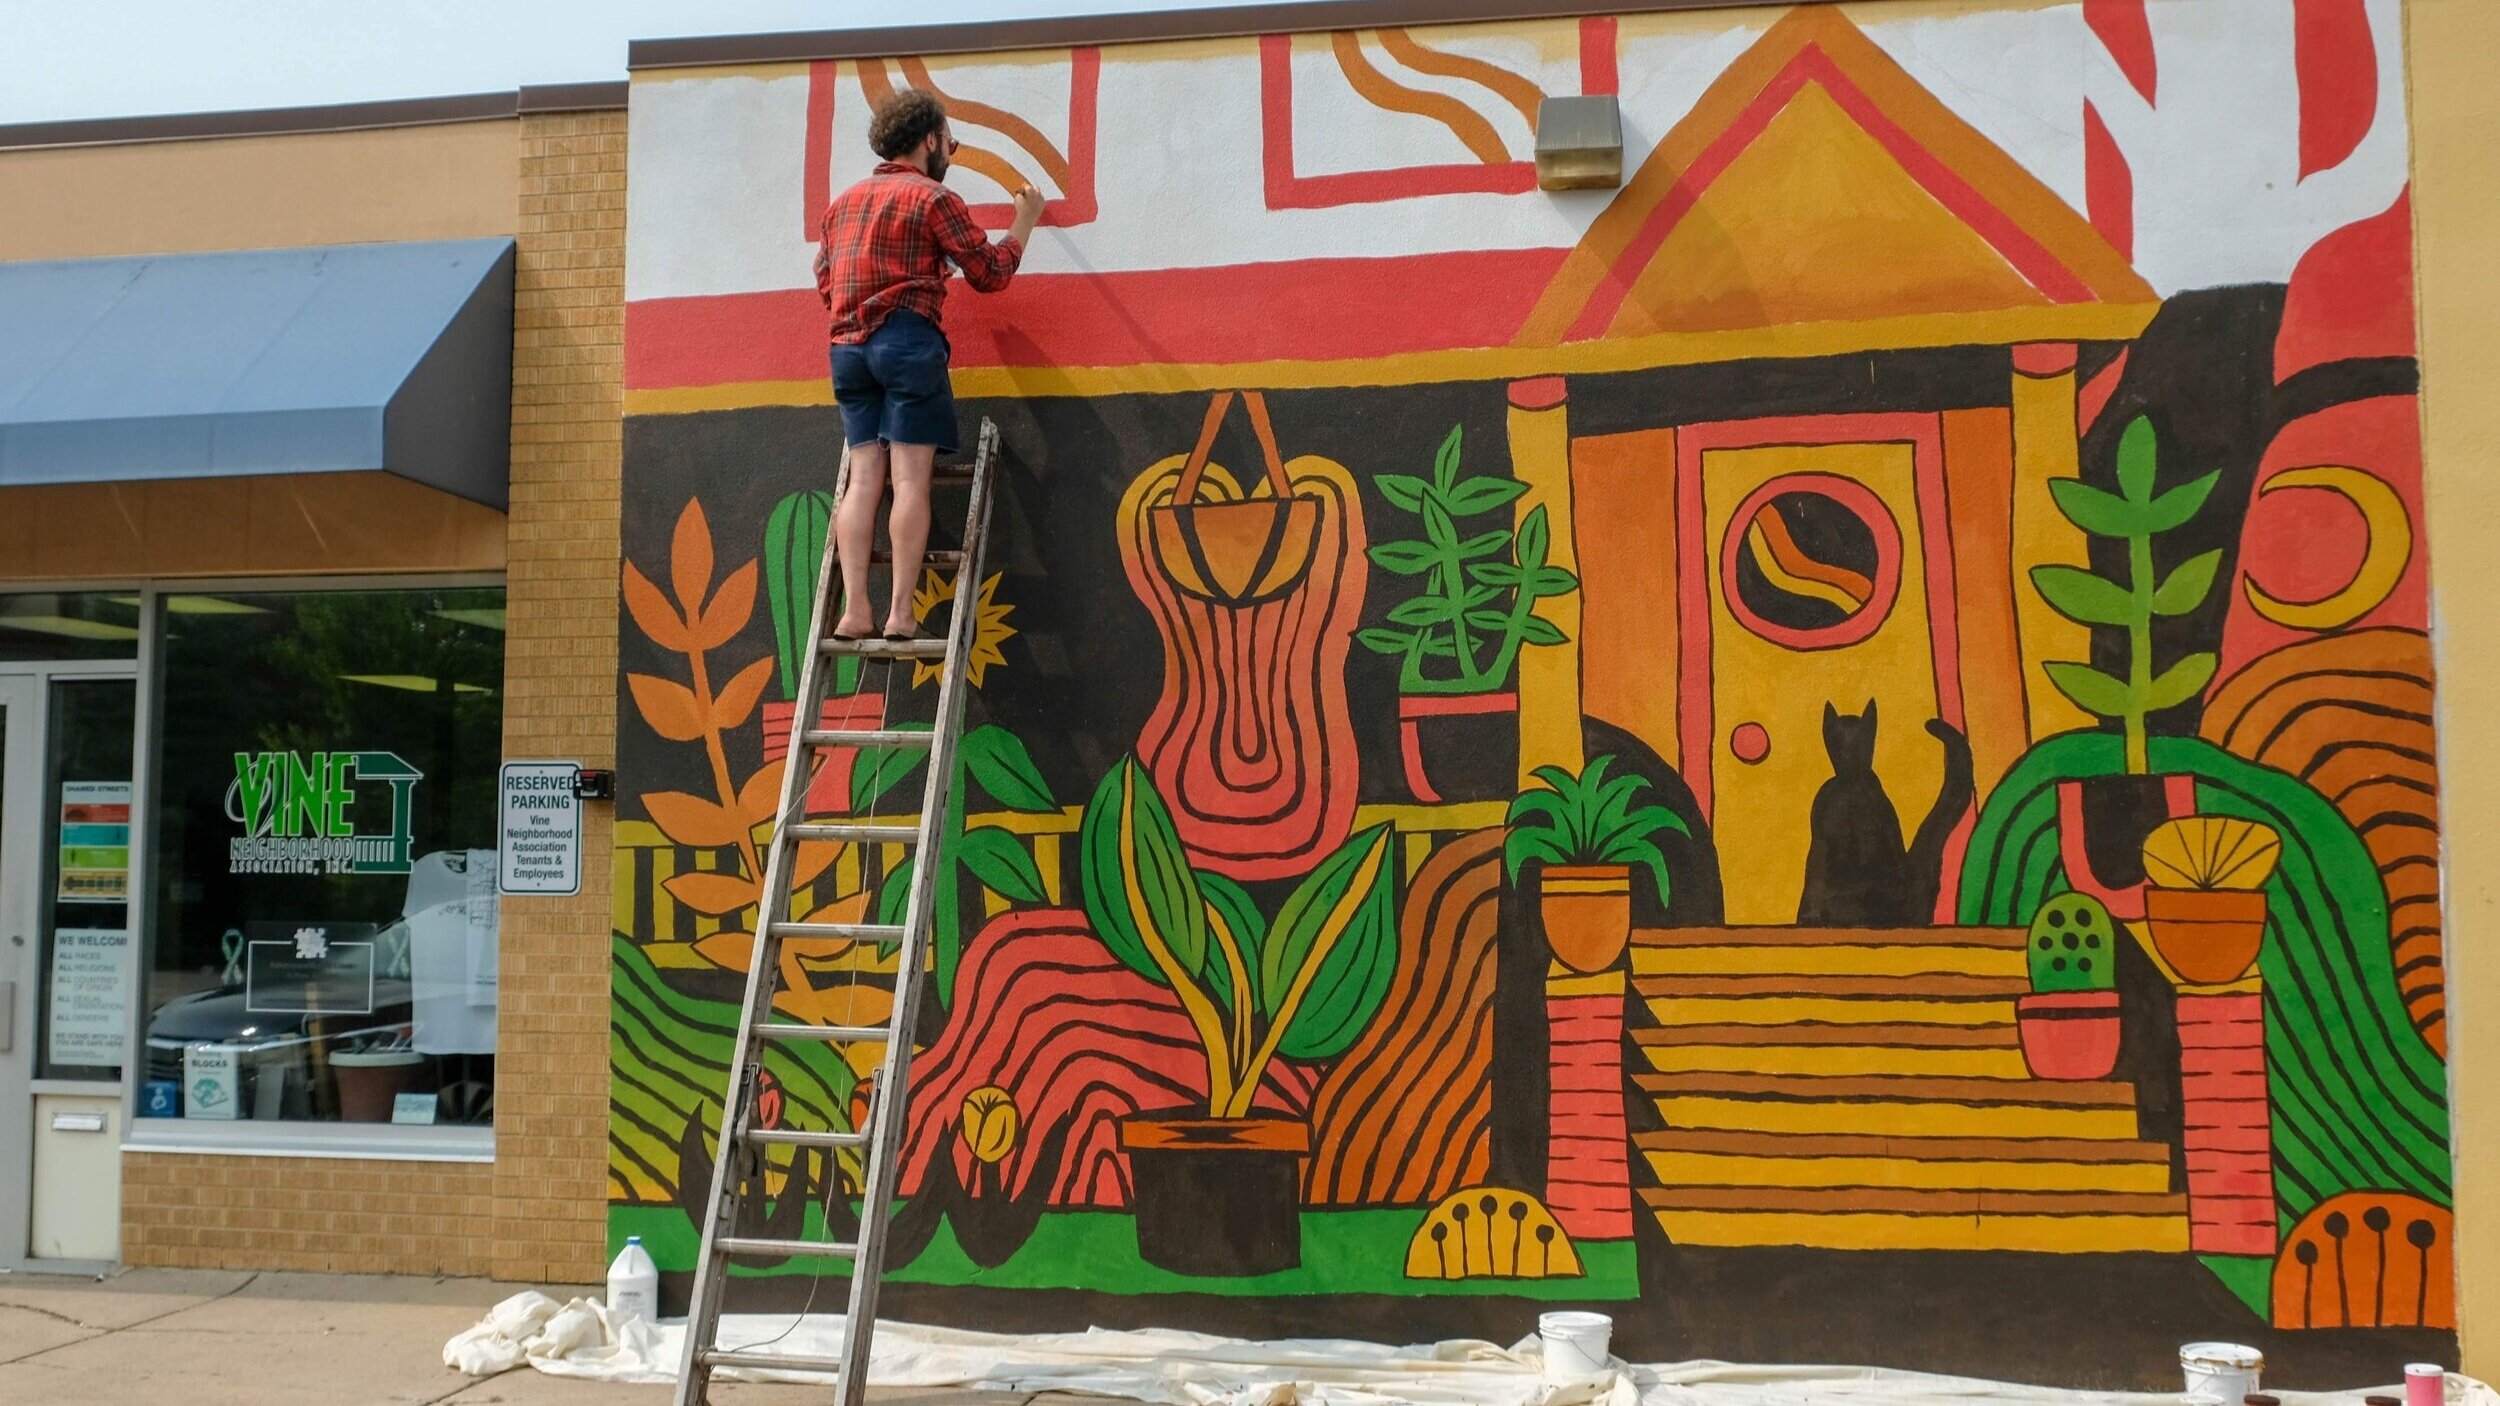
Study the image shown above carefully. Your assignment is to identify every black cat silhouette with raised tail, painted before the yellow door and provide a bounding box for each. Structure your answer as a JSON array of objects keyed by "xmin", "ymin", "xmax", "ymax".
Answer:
[{"xmin": 1798, "ymin": 700, "xmax": 1975, "ymax": 928}]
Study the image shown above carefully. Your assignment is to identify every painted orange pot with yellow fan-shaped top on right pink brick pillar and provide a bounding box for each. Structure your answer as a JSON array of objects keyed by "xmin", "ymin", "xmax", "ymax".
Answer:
[{"xmin": 2143, "ymin": 816, "xmax": 2283, "ymax": 986}]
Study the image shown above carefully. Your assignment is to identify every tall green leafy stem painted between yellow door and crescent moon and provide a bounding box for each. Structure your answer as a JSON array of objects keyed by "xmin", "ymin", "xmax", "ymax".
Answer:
[{"xmin": 2030, "ymin": 415, "xmax": 2223, "ymax": 776}]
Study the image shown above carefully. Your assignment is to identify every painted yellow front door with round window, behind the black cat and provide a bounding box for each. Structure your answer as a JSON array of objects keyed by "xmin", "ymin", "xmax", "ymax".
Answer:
[{"xmin": 1688, "ymin": 443, "xmax": 1945, "ymax": 923}]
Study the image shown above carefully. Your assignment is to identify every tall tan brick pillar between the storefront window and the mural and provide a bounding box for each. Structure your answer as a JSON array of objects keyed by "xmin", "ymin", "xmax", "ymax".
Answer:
[{"xmin": 488, "ymin": 113, "xmax": 625, "ymax": 1281}]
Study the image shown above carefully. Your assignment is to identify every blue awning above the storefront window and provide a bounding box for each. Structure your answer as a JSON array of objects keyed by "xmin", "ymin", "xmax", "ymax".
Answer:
[{"xmin": 0, "ymin": 240, "xmax": 513, "ymax": 508}]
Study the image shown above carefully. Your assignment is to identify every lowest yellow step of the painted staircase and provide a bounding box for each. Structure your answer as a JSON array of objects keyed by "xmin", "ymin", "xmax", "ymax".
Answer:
[{"xmin": 1640, "ymin": 1186, "xmax": 2188, "ymax": 1253}]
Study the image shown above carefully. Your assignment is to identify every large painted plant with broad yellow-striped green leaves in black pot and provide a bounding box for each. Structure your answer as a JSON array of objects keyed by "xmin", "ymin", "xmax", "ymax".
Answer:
[{"xmin": 1080, "ymin": 758, "xmax": 1398, "ymax": 1276}]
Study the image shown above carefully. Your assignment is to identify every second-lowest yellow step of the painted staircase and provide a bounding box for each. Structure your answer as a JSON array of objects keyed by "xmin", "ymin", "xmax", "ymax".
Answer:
[{"xmin": 1633, "ymin": 1128, "xmax": 2170, "ymax": 1196}]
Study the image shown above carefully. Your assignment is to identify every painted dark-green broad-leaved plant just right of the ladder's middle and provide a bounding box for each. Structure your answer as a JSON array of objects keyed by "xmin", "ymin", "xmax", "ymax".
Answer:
[{"xmin": 850, "ymin": 723, "xmax": 1060, "ymax": 1006}]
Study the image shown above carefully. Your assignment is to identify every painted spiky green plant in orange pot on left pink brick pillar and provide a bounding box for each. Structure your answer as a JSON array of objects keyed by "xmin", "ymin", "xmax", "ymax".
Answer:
[{"xmin": 1503, "ymin": 756, "xmax": 1693, "ymax": 971}]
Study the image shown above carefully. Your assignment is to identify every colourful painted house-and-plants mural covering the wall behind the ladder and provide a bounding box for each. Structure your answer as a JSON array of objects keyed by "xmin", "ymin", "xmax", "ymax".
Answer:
[{"xmin": 610, "ymin": 0, "xmax": 2455, "ymax": 1383}]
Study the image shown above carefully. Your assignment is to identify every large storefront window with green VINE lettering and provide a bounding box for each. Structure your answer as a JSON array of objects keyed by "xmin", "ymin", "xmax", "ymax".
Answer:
[{"xmin": 140, "ymin": 588, "xmax": 503, "ymax": 1126}]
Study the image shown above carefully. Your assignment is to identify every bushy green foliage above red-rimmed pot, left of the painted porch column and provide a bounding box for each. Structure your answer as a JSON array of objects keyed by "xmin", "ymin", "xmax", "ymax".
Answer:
[{"xmin": 1355, "ymin": 425, "xmax": 1580, "ymax": 693}]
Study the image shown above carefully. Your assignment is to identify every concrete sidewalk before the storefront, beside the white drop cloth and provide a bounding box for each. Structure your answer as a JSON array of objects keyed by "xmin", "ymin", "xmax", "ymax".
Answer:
[{"xmin": 0, "ymin": 1268, "xmax": 1103, "ymax": 1406}]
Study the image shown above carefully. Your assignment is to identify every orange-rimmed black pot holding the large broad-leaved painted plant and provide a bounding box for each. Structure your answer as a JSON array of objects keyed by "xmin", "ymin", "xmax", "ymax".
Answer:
[{"xmin": 1120, "ymin": 1113, "xmax": 1310, "ymax": 1278}]
